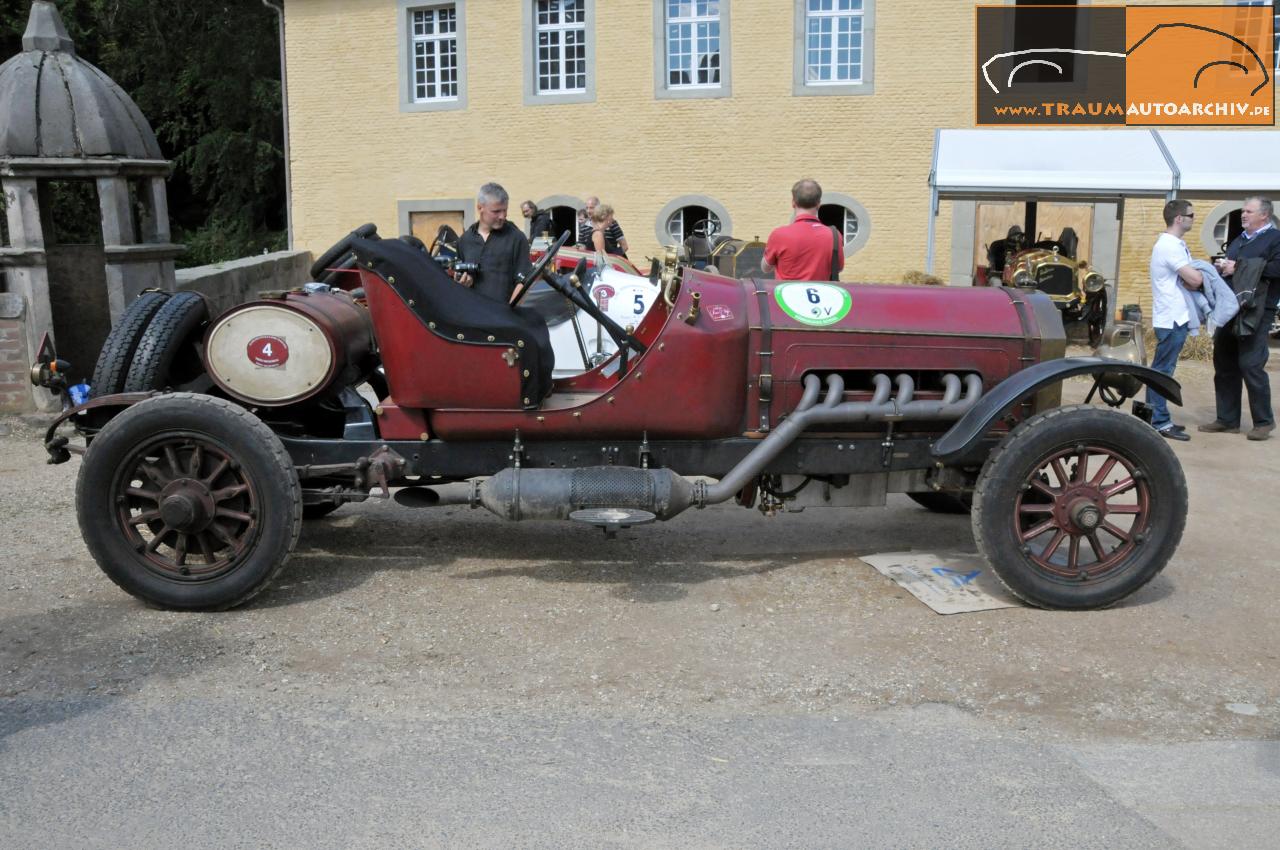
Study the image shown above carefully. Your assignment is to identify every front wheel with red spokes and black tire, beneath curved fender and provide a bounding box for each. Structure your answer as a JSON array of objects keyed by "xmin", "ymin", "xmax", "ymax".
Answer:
[{"xmin": 973, "ymin": 405, "xmax": 1187, "ymax": 608}]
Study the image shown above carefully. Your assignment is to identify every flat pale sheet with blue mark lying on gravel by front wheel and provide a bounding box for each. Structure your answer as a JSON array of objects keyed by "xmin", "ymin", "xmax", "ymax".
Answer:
[{"xmin": 860, "ymin": 552, "xmax": 1021, "ymax": 614}]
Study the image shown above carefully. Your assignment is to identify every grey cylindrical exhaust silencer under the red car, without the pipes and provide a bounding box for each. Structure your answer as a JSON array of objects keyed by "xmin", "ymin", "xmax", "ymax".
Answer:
[{"xmin": 471, "ymin": 466, "xmax": 694, "ymax": 521}]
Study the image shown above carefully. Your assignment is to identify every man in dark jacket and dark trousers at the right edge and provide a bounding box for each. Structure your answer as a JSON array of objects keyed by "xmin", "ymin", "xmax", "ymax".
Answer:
[{"xmin": 1199, "ymin": 196, "xmax": 1280, "ymax": 440}]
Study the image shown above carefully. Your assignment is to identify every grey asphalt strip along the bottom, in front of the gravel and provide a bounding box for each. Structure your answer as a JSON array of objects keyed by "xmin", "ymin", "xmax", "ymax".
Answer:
[{"xmin": 0, "ymin": 699, "xmax": 1280, "ymax": 850}]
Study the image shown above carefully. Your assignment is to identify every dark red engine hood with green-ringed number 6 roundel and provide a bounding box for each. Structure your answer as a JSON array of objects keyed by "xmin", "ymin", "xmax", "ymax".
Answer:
[{"xmin": 745, "ymin": 280, "xmax": 1066, "ymax": 430}]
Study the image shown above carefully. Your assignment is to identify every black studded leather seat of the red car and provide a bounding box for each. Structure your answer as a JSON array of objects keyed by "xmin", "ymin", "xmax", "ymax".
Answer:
[{"xmin": 352, "ymin": 232, "xmax": 556, "ymax": 407}]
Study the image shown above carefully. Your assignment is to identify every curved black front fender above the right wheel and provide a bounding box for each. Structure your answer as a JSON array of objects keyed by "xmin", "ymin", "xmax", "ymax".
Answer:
[{"xmin": 933, "ymin": 357, "xmax": 1183, "ymax": 462}]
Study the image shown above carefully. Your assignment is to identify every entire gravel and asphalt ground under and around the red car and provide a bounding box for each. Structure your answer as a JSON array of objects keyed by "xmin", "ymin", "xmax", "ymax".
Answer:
[{"xmin": 0, "ymin": 355, "xmax": 1280, "ymax": 850}]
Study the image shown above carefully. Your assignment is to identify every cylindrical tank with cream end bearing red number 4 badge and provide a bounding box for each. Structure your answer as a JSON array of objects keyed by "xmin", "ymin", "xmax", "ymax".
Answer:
[{"xmin": 205, "ymin": 289, "xmax": 375, "ymax": 407}]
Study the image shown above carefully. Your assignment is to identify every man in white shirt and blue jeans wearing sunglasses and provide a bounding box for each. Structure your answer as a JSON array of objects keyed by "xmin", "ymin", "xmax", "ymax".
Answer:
[{"xmin": 1147, "ymin": 201, "xmax": 1204, "ymax": 442}]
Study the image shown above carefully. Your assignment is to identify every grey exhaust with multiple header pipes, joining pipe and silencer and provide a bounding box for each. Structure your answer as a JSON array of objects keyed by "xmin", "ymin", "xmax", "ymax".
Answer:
[{"xmin": 470, "ymin": 374, "xmax": 982, "ymax": 521}]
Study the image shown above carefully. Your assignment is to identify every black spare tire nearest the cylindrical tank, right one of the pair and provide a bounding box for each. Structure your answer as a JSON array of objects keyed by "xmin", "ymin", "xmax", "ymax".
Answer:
[{"xmin": 124, "ymin": 292, "xmax": 209, "ymax": 393}]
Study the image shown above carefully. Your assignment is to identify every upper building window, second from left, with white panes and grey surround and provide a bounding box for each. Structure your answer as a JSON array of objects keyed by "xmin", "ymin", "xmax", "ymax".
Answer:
[{"xmin": 521, "ymin": 0, "xmax": 595, "ymax": 106}]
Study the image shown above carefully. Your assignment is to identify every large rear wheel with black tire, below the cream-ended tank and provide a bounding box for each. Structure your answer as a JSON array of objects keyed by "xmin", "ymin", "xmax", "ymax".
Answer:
[{"xmin": 76, "ymin": 393, "xmax": 302, "ymax": 611}]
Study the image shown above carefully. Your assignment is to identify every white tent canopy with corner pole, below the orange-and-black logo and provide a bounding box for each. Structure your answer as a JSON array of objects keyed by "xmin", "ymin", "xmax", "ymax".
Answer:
[{"xmin": 925, "ymin": 128, "xmax": 1280, "ymax": 271}]
